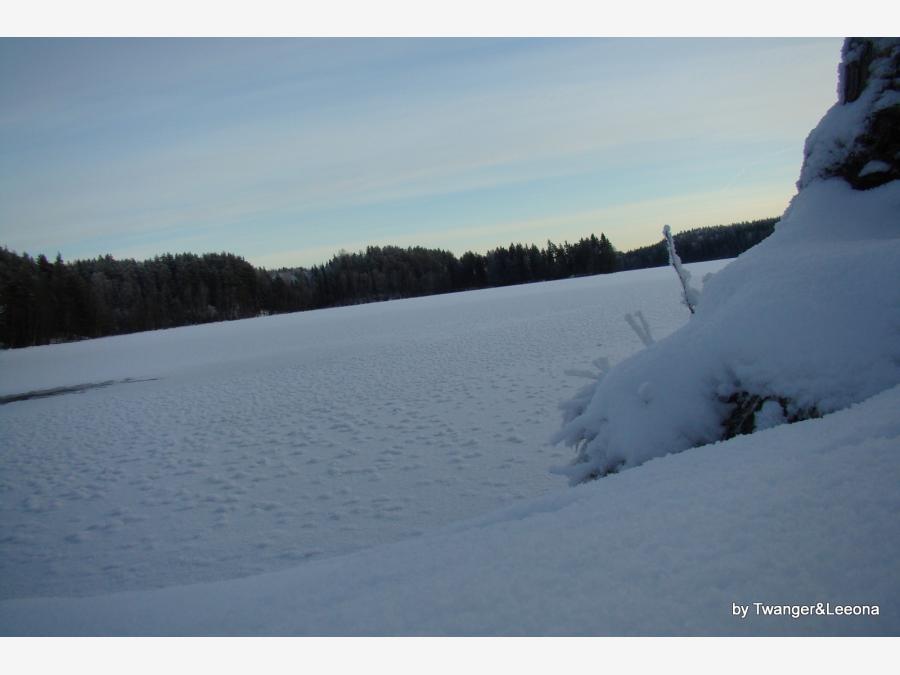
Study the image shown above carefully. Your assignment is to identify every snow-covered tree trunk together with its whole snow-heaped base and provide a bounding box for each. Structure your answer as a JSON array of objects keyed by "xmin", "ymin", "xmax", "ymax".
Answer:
[{"xmin": 554, "ymin": 39, "xmax": 900, "ymax": 483}]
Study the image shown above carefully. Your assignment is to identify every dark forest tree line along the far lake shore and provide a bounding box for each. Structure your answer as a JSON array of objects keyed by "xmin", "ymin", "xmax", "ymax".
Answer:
[{"xmin": 0, "ymin": 218, "xmax": 776, "ymax": 348}]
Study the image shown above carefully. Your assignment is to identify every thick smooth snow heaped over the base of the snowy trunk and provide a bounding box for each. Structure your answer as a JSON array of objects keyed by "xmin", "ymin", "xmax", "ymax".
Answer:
[{"xmin": 557, "ymin": 179, "xmax": 900, "ymax": 481}]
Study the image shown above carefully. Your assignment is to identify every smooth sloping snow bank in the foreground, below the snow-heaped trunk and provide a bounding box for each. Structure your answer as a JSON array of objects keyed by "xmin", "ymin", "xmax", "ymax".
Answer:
[{"xmin": 0, "ymin": 387, "xmax": 900, "ymax": 635}]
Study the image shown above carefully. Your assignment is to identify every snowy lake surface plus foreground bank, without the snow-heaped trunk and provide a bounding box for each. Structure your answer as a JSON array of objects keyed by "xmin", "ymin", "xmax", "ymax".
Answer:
[{"xmin": 0, "ymin": 255, "xmax": 900, "ymax": 635}]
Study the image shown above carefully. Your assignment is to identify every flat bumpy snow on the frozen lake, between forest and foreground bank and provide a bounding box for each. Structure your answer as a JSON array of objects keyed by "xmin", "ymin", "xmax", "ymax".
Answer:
[{"xmin": 0, "ymin": 262, "xmax": 724, "ymax": 604}]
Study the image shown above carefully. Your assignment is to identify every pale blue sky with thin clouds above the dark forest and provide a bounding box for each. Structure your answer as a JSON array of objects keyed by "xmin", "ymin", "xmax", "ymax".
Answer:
[{"xmin": 0, "ymin": 38, "xmax": 841, "ymax": 268}]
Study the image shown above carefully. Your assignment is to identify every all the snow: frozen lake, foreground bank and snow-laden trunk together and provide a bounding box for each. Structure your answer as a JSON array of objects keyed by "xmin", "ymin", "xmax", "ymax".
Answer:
[{"xmin": 0, "ymin": 39, "xmax": 900, "ymax": 635}]
